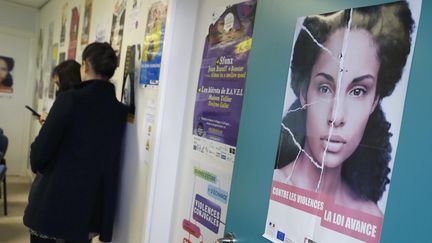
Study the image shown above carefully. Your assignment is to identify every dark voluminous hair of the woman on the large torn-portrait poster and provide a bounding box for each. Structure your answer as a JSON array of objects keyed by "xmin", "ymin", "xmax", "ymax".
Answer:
[{"xmin": 275, "ymin": 1, "xmax": 414, "ymax": 203}]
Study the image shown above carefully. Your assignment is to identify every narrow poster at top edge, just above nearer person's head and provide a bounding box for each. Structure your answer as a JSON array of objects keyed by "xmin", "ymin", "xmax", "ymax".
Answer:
[{"xmin": 110, "ymin": 0, "xmax": 126, "ymax": 63}]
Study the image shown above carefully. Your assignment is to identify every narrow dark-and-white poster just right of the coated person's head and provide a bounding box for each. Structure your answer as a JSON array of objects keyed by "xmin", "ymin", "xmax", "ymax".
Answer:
[{"xmin": 121, "ymin": 45, "xmax": 141, "ymax": 122}]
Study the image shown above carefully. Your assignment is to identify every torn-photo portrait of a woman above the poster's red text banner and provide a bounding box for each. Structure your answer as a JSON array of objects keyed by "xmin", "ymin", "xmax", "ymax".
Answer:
[{"xmin": 276, "ymin": 2, "xmax": 420, "ymax": 215}]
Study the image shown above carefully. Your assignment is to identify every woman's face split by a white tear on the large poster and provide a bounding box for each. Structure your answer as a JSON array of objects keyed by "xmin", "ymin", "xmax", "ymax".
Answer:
[{"xmin": 301, "ymin": 29, "xmax": 380, "ymax": 168}]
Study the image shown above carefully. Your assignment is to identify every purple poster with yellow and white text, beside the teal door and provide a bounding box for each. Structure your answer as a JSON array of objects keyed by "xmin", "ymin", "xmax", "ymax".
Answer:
[{"xmin": 193, "ymin": 0, "xmax": 256, "ymax": 162}]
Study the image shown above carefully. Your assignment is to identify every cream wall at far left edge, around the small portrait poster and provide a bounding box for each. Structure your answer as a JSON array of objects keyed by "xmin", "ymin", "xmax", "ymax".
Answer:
[{"xmin": 0, "ymin": 0, "xmax": 38, "ymax": 175}]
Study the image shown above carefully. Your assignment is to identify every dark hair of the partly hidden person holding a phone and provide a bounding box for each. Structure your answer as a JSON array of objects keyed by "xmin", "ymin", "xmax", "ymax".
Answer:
[{"xmin": 51, "ymin": 60, "xmax": 81, "ymax": 94}]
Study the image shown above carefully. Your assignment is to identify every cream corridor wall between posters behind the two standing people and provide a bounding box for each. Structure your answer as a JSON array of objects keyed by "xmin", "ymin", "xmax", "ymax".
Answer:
[{"xmin": 34, "ymin": 0, "xmax": 169, "ymax": 243}]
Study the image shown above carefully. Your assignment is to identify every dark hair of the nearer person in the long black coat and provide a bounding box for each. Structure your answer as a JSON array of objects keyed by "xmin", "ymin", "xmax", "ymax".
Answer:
[{"xmin": 82, "ymin": 42, "xmax": 118, "ymax": 79}]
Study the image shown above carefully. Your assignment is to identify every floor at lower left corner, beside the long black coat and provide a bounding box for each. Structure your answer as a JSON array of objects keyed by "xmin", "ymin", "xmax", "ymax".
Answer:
[{"xmin": 0, "ymin": 177, "xmax": 30, "ymax": 243}]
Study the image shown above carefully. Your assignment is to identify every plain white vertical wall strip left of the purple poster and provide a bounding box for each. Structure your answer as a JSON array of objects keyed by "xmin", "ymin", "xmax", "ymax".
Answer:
[{"xmin": 144, "ymin": 0, "xmax": 200, "ymax": 243}]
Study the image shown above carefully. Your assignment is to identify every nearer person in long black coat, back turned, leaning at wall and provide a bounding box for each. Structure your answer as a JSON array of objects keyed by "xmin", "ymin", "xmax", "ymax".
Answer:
[{"xmin": 24, "ymin": 43, "xmax": 127, "ymax": 243}]
